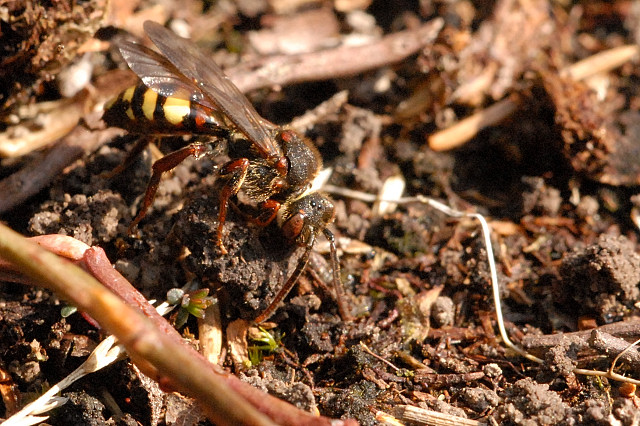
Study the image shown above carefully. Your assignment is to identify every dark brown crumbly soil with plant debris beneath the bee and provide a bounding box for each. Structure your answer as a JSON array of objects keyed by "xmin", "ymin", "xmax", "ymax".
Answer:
[{"xmin": 0, "ymin": 0, "xmax": 640, "ymax": 425}]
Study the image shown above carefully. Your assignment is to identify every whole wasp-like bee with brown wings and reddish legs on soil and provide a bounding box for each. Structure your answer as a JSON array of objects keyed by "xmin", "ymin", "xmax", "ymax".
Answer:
[{"xmin": 102, "ymin": 21, "xmax": 350, "ymax": 323}]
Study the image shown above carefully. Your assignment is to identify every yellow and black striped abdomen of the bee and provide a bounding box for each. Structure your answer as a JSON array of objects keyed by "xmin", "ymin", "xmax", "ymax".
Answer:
[{"xmin": 102, "ymin": 84, "xmax": 228, "ymax": 136}]
